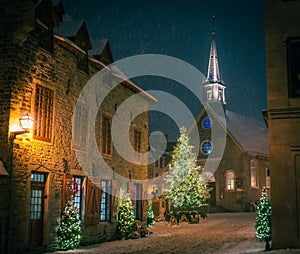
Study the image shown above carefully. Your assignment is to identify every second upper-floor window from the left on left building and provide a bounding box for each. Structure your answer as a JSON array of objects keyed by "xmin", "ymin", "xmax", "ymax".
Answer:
[{"xmin": 73, "ymin": 103, "xmax": 88, "ymax": 149}]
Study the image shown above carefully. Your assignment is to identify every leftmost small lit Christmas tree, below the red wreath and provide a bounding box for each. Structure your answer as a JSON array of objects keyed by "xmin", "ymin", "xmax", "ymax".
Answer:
[{"xmin": 57, "ymin": 201, "xmax": 81, "ymax": 250}]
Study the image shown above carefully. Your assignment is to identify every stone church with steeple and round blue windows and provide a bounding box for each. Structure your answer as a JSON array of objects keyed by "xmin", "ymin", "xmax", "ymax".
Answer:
[{"xmin": 190, "ymin": 25, "xmax": 271, "ymax": 211}]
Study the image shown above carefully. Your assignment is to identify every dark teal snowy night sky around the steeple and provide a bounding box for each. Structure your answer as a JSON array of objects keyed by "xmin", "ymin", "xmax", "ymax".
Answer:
[{"xmin": 63, "ymin": 0, "xmax": 267, "ymax": 140}]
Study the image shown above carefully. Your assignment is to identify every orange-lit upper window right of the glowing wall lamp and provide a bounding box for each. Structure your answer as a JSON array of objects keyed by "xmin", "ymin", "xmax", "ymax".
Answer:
[{"xmin": 34, "ymin": 85, "xmax": 54, "ymax": 142}]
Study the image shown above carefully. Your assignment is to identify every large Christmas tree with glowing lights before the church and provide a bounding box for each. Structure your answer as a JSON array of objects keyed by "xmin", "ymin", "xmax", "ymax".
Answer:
[{"xmin": 165, "ymin": 128, "xmax": 210, "ymax": 211}]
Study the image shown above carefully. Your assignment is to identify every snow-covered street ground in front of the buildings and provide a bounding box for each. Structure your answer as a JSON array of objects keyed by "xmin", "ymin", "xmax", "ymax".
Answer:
[{"xmin": 49, "ymin": 213, "xmax": 300, "ymax": 254}]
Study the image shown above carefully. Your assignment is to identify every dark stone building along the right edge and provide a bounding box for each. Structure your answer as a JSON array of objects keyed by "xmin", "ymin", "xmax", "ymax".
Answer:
[{"xmin": 265, "ymin": 0, "xmax": 300, "ymax": 249}]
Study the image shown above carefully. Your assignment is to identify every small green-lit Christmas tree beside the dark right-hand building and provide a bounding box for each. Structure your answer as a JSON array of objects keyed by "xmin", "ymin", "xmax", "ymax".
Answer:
[{"xmin": 255, "ymin": 187, "xmax": 272, "ymax": 251}]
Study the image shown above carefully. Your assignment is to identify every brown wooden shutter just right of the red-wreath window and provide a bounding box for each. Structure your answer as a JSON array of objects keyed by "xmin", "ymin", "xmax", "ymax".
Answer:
[{"xmin": 84, "ymin": 180, "xmax": 101, "ymax": 225}]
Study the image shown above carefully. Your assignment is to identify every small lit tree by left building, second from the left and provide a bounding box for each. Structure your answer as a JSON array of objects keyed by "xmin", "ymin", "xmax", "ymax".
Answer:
[{"xmin": 117, "ymin": 193, "xmax": 137, "ymax": 239}]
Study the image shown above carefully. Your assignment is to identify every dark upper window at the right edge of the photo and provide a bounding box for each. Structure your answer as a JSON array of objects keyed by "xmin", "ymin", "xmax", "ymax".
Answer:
[{"xmin": 287, "ymin": 38, "xmax": 300, "ymax": 98}]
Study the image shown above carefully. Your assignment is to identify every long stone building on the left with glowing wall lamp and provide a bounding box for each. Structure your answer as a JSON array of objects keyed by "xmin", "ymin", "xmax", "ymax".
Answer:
[{"xmin": 0, "ymin": 0, "xmax": 156, "ymax": 253}]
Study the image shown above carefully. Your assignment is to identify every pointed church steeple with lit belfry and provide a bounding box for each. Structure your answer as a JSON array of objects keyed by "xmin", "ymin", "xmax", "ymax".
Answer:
[{"xmin": 203, "ymin": 16, "xmax": 226, "ymax": 108}]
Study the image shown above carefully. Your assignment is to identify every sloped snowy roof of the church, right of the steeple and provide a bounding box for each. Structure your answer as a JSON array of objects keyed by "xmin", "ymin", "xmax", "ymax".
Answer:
[{"xmin": 226, "ymin": 110, "xmax": 268, "ymax": 155}]
